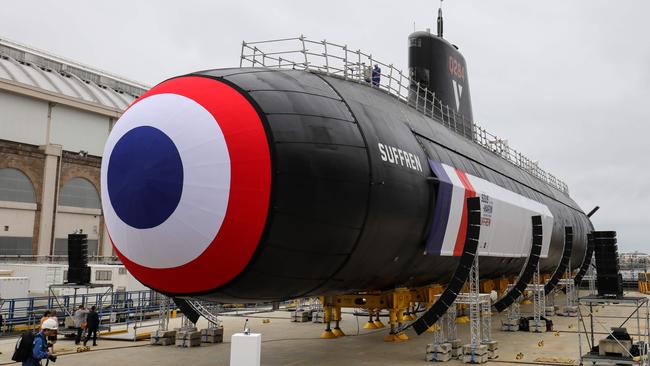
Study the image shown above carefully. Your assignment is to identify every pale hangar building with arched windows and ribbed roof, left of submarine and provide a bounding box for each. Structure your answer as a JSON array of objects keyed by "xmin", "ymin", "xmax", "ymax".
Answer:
[{"xmin": 0, "ymin": 39, "xmax": 148, "ymax": 258}]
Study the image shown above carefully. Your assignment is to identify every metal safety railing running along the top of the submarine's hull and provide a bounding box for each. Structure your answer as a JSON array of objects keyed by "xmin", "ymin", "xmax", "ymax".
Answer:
[{"xmin": 239, "ymin": 35, "xmax": 569, "ymax": 194}]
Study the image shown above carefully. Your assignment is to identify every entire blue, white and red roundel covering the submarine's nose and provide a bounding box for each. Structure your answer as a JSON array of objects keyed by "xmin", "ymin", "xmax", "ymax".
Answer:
[{"xmin": 101, "ymin": 76, "xmax": 271, "ymax": 294}]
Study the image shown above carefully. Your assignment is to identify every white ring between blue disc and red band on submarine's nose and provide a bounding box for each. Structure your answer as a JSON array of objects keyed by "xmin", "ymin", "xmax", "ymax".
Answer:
[{"xmin": 101, "ymin": 94, "xmax": 230, "ymax": 268}]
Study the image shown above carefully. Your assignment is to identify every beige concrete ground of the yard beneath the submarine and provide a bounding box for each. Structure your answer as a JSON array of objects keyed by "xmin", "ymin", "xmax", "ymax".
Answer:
[{"xmin": 0, "ymin": 293, "xmax": 647, "ymax": 366}]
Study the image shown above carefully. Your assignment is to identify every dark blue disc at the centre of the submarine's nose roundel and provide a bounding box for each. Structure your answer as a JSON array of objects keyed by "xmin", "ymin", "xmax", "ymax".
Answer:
[{"xmin": 107, "ymin": 126, "xmax": 183, "ymax": 229}]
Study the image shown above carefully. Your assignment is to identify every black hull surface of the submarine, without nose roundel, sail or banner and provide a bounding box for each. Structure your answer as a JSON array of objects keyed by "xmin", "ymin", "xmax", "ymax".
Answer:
[{"xmin": 102, "ymin": 68, "xmax": 591, "ymax": 302}]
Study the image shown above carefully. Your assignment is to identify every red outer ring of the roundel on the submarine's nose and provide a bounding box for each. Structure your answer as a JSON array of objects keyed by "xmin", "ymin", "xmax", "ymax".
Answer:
[{"xmin": 111, "ymin": 76, "xmax": 271, "ymax": 294}]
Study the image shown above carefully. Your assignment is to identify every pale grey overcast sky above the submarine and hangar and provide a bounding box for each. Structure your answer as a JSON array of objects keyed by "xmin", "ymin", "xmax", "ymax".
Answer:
[{"xmin": 0, "ymin": 0, "xmax": 650, "ymax": 251}]
